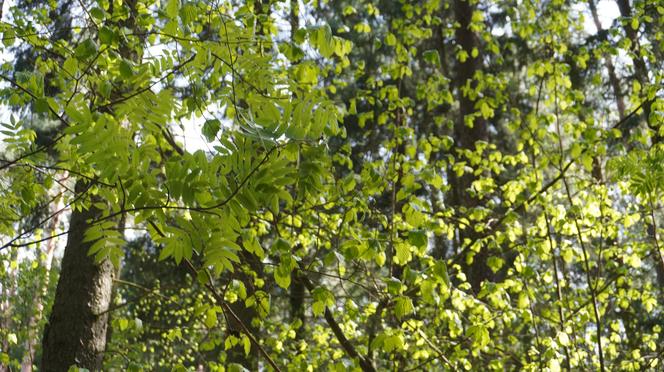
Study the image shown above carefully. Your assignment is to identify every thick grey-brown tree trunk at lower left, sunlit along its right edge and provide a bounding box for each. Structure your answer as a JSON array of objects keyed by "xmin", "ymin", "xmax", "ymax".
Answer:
[{"xmin": 41, "ymin": 181, "xmax": 115, "ymax": 372}]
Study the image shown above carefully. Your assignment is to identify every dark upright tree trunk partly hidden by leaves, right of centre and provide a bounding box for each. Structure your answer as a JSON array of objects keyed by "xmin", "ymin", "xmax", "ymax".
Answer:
[{"xmin": 449, "ymin": 0, "xmax": 491, "ymax": 291}]
